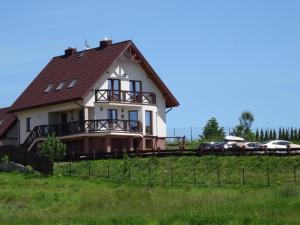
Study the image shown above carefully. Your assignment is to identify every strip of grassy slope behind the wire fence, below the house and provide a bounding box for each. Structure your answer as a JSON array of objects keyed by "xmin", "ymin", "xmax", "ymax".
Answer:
[{"xmin": 55, "ymin": 156, "xmax": 300, "ymax": 187}]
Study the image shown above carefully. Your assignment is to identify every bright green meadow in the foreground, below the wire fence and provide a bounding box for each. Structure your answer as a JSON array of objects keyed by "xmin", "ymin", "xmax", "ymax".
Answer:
[{"xmin": 0, "ymin": 174, "xmax": 300, "ymax": 225}]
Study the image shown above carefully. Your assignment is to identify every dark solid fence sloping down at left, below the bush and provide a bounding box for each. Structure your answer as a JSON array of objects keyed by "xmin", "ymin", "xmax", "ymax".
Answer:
[{"xmin": 0, "ymin": 145, "xmax": 53, "ymax": 175}]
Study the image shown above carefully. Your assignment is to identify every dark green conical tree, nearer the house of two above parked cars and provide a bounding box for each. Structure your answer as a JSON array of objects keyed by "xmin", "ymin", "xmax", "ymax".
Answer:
[{"xmin": 200, "ymin": 117, "xmax": 225, "ymax": 141}]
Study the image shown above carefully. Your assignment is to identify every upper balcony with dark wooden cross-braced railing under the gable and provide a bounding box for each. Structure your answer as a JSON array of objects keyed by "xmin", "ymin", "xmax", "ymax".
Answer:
[{"xmin": 95, "ymin": 90, "xmax": 156, "ymax": 105}]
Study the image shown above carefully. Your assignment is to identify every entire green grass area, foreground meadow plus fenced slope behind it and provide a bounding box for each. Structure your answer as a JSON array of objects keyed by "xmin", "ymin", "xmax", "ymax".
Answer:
[{"xmin": 0, "ymin": 157, "xmax": 300, "ymax": 225}]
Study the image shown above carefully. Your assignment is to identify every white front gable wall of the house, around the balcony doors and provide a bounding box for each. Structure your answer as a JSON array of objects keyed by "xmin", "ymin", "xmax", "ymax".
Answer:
[{"xmin": 84, "ymin": 56, "xmax": 167, "ymax": 137}]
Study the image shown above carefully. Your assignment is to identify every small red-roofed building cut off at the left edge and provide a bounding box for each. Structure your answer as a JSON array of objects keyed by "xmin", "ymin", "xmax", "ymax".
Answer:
[{"xmin": 0, "ymin": 108, "xmax": 18, "ymax": 146}]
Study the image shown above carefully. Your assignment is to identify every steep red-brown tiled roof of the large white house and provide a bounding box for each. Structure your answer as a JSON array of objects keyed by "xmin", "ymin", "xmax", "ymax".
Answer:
[{"xmin": 11, "ymin": 41, "xmax": 179, "ymax": 112}]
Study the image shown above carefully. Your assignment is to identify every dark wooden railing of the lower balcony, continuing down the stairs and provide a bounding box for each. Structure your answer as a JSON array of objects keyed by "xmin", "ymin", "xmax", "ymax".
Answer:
[{"xmin": 23, "ymin": 119, "xmax": 143, "ymax": 149}]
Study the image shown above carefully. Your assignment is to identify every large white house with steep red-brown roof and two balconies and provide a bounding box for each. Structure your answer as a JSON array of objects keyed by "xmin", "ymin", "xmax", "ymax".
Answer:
[{"xmin": 10, "ymin": 40, "xmax": 179, "ymax": 154}]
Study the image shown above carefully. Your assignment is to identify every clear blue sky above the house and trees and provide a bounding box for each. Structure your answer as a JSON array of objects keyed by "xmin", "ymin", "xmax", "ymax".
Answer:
[{"xmin": 0, "ymin": 0, "xmax": 300, "ymax": 128}]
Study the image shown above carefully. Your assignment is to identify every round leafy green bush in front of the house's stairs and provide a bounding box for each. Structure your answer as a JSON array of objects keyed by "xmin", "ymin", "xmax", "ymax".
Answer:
[{"xmin": 38, "ymin": 134, "xmax": 66, "ymax": 161}]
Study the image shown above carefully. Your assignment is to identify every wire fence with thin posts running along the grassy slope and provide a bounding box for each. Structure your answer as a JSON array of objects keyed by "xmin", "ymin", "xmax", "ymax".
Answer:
[{"xmin": 56, "ymin": 158, "xmax": 299, "ymax": 187}]
